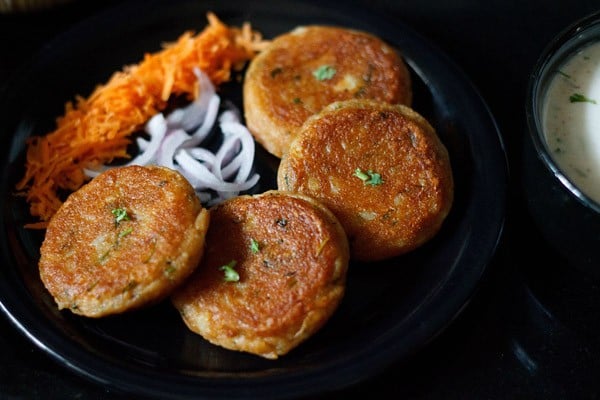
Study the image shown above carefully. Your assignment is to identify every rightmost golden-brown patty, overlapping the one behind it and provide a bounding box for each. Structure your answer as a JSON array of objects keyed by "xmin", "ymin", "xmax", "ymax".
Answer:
[{"xmin": 278, "ymin": 100, "xmax": 454, "ymax": 261}]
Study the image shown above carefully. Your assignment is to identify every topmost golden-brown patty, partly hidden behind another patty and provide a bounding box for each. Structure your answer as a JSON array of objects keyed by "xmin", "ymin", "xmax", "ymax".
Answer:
[{"xmin": 243, "ymin": 25, "xmax": 412, "ymax": 157}]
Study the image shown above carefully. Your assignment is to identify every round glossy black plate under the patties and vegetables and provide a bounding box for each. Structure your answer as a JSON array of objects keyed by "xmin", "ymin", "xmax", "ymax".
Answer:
[{"xmin": 0, "ymin": 0, "xmax": 507, "ymax": 399}]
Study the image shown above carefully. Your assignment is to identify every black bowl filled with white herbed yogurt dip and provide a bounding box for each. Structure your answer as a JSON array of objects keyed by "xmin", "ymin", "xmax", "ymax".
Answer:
[{"xmin": 524, "ymin": 12, "xmax": 600, "ymax": 277}]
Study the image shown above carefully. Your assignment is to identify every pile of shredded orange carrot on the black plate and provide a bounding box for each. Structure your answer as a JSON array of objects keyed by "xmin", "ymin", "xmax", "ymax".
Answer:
[{"xmin": 16, "ymin": 12, "xmax": 266, "ymax": 228}]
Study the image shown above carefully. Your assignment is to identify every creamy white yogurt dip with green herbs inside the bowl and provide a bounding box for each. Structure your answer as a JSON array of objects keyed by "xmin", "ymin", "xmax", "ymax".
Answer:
[{"xmin": 542, "ymin": 42, "xmax": 600, "ymax": 203}]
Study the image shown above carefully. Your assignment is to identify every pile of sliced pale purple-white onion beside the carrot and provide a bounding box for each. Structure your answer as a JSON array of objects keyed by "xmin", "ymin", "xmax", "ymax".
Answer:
[{"xmin": 84, "ymin": 70, "xmax": 260, "ymax": 206}]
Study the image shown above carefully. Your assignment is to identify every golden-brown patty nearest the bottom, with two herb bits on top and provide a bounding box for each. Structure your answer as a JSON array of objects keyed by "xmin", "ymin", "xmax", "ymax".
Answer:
[{"xmin": 172, "ymin": 191, "xmax": 349, "ymax": 359}]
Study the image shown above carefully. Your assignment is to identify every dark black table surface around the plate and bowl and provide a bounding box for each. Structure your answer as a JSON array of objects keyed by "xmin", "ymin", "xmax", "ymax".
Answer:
[{"xmin": 0, "ymin": 0, "xmax": 600, "ymax": 399}]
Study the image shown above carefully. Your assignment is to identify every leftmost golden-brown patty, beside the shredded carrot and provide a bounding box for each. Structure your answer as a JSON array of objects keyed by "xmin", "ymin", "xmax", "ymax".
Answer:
[{"xmin": 39, "ymin": 166, "xmax": 209, "ymax": 317}]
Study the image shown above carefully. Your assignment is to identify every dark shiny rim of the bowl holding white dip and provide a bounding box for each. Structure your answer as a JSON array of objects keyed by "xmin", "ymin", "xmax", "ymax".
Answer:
[{"xmin": 525, "ymin": 10, "xmax": 600, "ymax": 213}]
